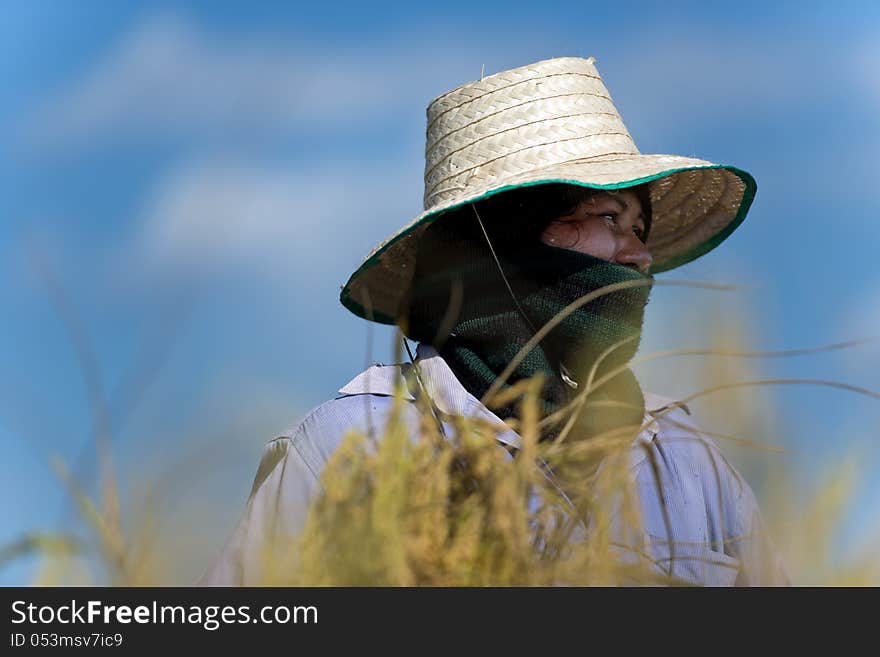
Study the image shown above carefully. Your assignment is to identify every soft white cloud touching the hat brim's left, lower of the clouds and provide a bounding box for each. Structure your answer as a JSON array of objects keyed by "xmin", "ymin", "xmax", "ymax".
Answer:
[{"xmin": 135, "ymin": 161, "xmax": 421, "ymax": 284}]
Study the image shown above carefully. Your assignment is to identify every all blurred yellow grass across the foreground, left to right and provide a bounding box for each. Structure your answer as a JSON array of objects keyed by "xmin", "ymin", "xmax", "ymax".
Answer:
[{"xmin": 6, "ymin": 292, "xmax": 880, "ymax": 586}]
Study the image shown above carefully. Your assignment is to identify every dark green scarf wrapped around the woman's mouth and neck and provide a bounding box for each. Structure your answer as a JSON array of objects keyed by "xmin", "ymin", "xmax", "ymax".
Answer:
[{"xmin": 398, "ymin": 215, "xmax": 653, "ymax": 446}]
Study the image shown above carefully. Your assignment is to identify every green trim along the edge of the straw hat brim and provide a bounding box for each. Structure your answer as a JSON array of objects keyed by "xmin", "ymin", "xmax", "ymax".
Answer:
[{"xmin": 339, "ymin": 164, "xmax": 758, "ymax": 326}]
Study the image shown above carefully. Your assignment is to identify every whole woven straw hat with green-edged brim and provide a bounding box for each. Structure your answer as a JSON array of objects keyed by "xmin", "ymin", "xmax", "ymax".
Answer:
[{"xmin": 340, "ymin": 57, "xmax": 756, "ymax": 324}]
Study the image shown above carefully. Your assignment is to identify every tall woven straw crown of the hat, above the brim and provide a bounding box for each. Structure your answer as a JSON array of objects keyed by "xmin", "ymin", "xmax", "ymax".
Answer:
[{"xmin": 424, "ymin": 57, "xmax": 639, "ymax": 210}]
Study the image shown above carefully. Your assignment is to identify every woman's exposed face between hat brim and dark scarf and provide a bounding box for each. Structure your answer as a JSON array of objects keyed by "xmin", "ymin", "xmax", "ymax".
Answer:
[{"xmin": 541, "ymin": 189, "xmax": 652, "ymax": 274}]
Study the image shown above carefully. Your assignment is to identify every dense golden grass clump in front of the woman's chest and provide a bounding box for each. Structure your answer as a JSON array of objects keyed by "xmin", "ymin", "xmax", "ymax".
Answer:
[{"xmin": 266, "ymin": 380, "xmax": 661, "ymax": 586}]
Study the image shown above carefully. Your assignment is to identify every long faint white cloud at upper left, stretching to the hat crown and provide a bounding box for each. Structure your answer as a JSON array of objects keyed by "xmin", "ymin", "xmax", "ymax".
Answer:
[{"xmin": 25, "ymin": 14, "xmax": 496, "ymax": 147}]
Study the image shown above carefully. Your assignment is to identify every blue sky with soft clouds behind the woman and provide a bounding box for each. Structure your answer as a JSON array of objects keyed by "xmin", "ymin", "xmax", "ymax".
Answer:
[{"xmin": 0, "ymin": 2, "xmax": 880, "ymax": 584}]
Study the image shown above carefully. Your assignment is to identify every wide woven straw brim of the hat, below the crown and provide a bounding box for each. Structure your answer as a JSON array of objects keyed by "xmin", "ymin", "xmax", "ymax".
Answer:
[{"xmin": 340, "ymin": 154, "xmax": 757, "ymax": 325}]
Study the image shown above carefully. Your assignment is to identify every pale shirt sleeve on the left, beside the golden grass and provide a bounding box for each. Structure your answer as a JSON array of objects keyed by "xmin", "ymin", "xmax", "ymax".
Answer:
[{"xmin": 199, "ymin": 435, "xmax": 321, "ymax": 586}]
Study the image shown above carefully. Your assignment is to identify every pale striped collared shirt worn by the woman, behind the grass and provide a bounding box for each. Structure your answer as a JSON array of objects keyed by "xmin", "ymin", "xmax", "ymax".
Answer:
[{"xmin": 200, "ymin": 345, "xmax": 788, "ymax": 586}]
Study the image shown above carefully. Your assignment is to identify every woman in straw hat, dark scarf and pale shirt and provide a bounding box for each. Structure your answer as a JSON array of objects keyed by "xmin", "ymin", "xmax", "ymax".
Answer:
[{"xmin": 202, "ymin": 58, "xmax": 787, "ymax": 585}]
